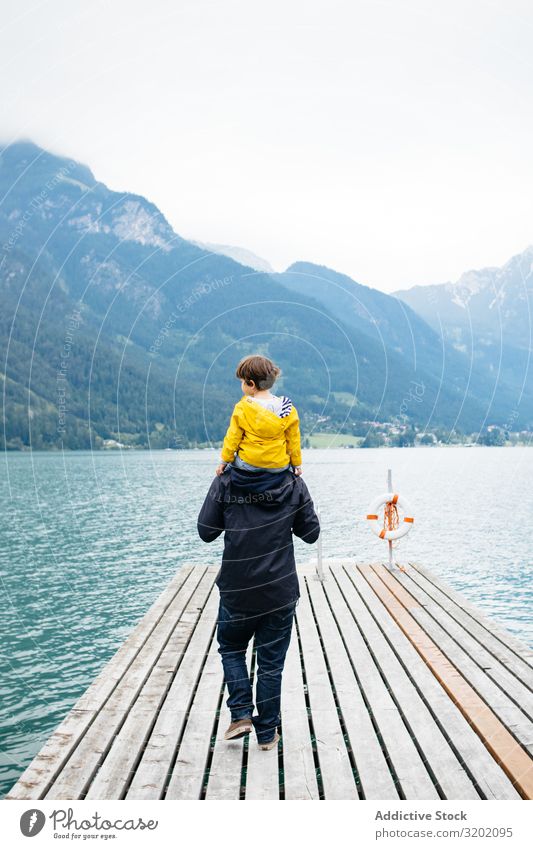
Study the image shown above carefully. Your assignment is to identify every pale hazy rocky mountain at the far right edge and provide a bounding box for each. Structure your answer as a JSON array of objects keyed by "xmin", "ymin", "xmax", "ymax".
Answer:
[{"xmin": 395, "ymin": 246, "xmax": 533, "ymax": 425}]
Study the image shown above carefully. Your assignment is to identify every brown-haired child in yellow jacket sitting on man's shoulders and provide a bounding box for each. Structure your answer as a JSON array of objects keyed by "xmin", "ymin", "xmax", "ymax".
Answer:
[{"xmin": 216, "ymin": 355, "xmax": 302, "ymax": 476}]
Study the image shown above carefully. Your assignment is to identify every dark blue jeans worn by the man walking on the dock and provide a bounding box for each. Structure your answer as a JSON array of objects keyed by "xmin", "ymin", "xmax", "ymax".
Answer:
[{"xmin": 217, "ymin": 600, "xmax": 298, "ymax": 743}]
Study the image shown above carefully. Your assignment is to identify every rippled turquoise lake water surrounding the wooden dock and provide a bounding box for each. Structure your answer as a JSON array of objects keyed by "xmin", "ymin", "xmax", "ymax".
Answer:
[{"xmin": 0, "ymin": 447, "xmax": 533, "ymax": 795}]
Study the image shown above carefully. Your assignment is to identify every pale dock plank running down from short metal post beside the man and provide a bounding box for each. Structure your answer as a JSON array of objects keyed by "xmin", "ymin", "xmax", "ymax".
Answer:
[{"xmin": 307, "ymin": 571, "xmax": 399, "ymax": 799}]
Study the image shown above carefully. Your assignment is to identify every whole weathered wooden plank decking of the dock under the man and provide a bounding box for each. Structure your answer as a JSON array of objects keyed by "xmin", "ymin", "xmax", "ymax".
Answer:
[{"xmin": 6, "ymin": 560, "xmax": 533, "ymax": 800}]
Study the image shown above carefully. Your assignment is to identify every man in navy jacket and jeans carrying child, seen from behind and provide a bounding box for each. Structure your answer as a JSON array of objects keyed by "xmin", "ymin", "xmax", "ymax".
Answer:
[{"xmin": 198, "ymin": 465, "xmax": 320, "ymax": 750}]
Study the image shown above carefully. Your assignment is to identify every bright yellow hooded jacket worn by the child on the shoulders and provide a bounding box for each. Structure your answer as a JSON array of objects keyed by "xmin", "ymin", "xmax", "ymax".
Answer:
[{"xmin": 221, "ymin": 395, "xmax": 302, "ymax": 469}]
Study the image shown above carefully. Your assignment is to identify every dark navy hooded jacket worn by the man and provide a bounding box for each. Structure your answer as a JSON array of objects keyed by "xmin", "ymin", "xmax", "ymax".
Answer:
[{"xmin": 198, "ymin": 466, "xmax": 320, "ymax": 613}]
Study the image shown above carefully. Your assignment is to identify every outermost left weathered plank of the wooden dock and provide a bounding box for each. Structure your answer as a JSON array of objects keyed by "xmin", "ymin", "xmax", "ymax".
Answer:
[{"xmin": 5, "ymin": 564, "xmax": 197, "ymax": 799}]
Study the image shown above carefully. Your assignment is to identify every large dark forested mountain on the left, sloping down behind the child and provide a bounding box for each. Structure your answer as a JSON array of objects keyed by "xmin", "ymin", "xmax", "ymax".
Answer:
[{"xmin": 0, "ymin": 142, "xmax": 524, "ymax": 448}]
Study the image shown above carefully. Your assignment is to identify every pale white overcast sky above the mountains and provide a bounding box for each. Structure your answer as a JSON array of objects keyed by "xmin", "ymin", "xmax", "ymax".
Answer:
[{"xmin": 0, "ymin": 0, "xmax": 533, "ymax": 291}]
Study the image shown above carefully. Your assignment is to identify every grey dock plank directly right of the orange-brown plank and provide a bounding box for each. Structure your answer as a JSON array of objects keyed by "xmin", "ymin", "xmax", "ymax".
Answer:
[{"xmin": 374, "ymin": 566, "xmax": 533, "ymax": 752}]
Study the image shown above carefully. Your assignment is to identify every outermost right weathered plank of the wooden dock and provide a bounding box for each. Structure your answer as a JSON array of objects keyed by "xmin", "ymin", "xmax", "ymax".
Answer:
[{"xmin": 404, "ymin": 566, "xmax": 533, "ymax": 690}]
